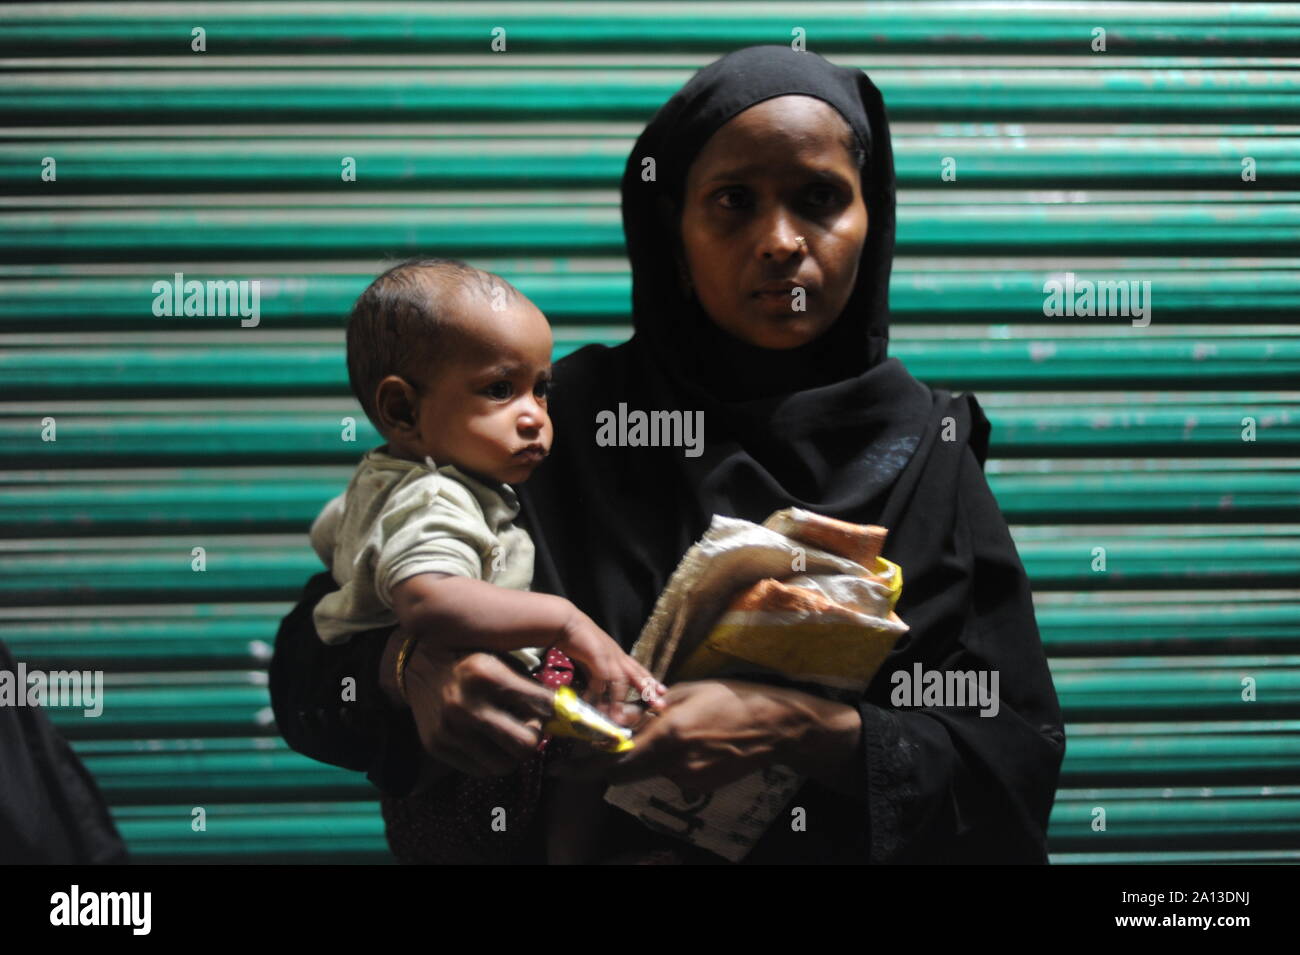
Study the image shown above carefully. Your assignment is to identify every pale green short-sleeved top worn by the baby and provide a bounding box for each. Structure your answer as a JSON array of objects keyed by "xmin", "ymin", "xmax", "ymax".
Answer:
[{"xmin": 311, "ymin": 444, "xmax": 542, "ymax": 669}]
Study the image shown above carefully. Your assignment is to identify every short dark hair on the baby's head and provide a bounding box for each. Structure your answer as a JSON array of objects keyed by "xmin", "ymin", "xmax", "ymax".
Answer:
[{"xmin": 347, "ymin": 259, "xmax": 521, "ymax": 430}]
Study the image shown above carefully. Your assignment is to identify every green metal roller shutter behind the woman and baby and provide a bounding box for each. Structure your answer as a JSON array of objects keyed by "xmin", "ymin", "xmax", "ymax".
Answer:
[{"xmin": 0, "ymin": 3, "xmax": 1300, "ymax": 863}]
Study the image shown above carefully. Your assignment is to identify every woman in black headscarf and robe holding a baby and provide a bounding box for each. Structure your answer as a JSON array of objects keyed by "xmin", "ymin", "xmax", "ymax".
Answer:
[{"xmin": 272, "ymin": 47, "xmax": 1065, "ymax": 863}]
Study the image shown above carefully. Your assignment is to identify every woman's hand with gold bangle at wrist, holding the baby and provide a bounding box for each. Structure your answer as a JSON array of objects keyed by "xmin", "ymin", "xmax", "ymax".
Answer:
[{"xmin": 385, "ymin": 630, "xmax": 554, "ymax": 777}]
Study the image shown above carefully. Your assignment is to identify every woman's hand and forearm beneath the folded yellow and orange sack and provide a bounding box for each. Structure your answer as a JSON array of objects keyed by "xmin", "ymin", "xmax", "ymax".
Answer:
[{"xmin": 555, "ymin": 680, "xmax": 862, "ymax": 793}]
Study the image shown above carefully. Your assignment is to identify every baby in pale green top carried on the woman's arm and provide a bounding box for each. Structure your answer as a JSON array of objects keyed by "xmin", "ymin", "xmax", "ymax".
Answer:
[{"xmin": 311, "ymin": 259, "xmax": 666, "ymax": 715}]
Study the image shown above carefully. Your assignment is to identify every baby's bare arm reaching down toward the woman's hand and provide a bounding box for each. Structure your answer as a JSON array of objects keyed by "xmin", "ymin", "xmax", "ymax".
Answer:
[{"xmin": 393, "ymin": 573, "xmax": 666, "ymax": 702}]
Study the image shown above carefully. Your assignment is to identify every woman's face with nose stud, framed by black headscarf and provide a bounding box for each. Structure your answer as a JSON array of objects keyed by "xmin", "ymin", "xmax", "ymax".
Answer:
[{"xmin": 681, "ymin": 95, "xmax": 867, "ymax": 348}]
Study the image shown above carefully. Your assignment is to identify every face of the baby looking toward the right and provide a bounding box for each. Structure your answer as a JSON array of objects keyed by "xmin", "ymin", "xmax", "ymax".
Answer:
[{"xmin": 417, "ymin": 298, "xmax": 551, "ymax": 485}]
